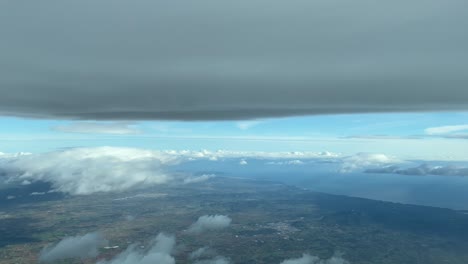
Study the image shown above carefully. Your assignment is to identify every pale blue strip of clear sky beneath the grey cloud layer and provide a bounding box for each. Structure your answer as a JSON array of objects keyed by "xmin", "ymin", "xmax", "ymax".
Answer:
[{"xmin": 0, "ymin": 112, "xmax": 468, "ymax": 160}]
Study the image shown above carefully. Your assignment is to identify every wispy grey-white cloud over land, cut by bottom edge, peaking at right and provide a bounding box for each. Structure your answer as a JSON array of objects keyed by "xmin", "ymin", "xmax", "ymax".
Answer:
[{"xmin": 97, "ymin": 233, "xmax": 175, "ymax": 264}]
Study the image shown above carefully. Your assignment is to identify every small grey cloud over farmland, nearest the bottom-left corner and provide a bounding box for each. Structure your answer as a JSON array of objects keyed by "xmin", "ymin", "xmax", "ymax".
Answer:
[{"xmin": 39, "ymin": 233, "xmax": 107, "ymax": 262}]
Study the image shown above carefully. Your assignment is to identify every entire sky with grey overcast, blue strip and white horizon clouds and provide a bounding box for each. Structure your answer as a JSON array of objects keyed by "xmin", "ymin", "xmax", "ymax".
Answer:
[{"xmin": 0, "ymin": 0, "xmax": 468, "ymax": 204}]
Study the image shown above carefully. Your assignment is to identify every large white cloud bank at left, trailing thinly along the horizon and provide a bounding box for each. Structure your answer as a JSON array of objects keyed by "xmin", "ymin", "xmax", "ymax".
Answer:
[{"xmin": 0, "ymin": 147, "xmax": 338, "ymax": 195}]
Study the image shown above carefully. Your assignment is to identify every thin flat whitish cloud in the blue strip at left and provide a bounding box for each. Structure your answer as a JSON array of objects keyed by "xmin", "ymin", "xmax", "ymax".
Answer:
[{"xmin": 52, "ymin": 122, "xmax": 141, "ymax": 135}]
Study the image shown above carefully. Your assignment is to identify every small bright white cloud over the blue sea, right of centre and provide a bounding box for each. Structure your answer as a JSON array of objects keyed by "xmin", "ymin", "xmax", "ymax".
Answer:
[{"xmin": 340, "ymin": 153, "xmax": 402, "ymax": 173}]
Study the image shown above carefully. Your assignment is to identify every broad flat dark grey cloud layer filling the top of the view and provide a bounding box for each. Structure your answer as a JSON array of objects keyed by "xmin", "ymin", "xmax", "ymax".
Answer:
[{"xmin": 0, "ymin": 0, "xmax": 468, "ymax": 120}]
